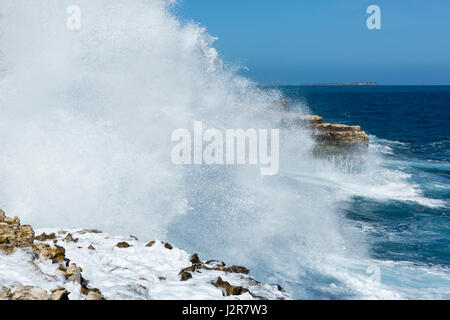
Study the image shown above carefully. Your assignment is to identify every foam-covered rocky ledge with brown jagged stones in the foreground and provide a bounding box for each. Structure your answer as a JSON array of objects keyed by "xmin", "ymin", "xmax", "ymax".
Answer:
[{"xmin": 0, "ymin": 210, "xmax": 289, "ymax": 300}]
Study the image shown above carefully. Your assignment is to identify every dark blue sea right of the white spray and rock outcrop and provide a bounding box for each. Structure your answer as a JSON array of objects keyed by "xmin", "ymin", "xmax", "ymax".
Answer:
[{"xmin": 278, "ymin": 86, "xmax": 450, "ymax": 293}]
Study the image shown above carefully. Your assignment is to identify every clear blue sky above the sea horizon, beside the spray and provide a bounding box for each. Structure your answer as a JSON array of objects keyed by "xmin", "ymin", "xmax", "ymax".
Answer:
[{"xmin": 175, "ymin": 0, "xmax": 450, "ymax": 85}]
